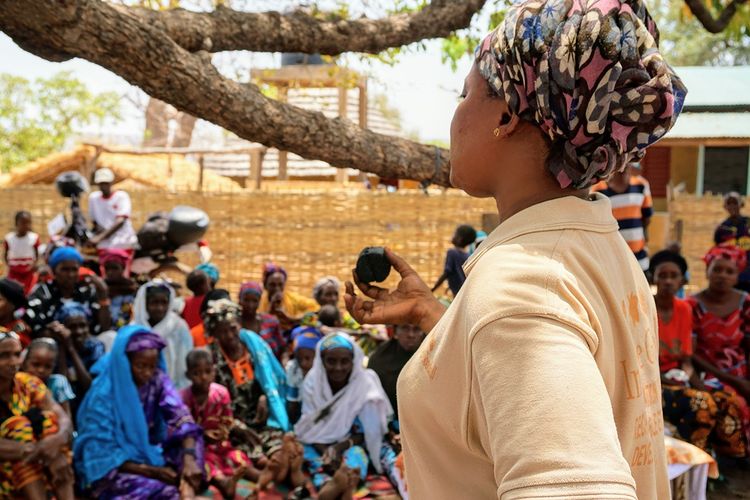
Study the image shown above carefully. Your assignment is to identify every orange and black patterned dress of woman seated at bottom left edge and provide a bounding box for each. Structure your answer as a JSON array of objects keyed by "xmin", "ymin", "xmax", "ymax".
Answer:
[{"xmin": 0, "ymin": 372, "xmax": 67, "ymax": 498}]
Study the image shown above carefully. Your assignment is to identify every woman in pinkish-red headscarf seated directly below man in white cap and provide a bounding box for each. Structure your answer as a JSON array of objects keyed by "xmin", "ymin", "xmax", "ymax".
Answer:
[{"xmin": 99, "ymin": 248, "xmax": 138, "ymax": 329}]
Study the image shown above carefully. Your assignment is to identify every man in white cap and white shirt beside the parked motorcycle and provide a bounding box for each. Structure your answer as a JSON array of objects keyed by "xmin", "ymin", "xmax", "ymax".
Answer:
[{"xmin": 89, "ymin": 168, "xmax": 138, "ymax": 276}]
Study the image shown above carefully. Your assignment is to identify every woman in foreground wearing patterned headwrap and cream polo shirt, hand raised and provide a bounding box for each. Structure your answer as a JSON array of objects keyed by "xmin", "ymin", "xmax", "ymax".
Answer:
[{"xmin": 346, "ymin": 0, "xmax": 686, "ymax": 499}]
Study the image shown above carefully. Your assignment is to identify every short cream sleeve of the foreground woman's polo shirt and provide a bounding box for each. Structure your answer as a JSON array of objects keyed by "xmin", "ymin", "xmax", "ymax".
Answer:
[{"xmin": 469, "ymin": 315, "xmax": 636, "ymax": 500}]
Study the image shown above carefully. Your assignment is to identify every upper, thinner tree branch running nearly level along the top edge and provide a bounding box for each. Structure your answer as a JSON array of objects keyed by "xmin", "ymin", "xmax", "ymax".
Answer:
[{"xmin": 125, "ymin": 0, "xmax": 487, "ymax": 55}]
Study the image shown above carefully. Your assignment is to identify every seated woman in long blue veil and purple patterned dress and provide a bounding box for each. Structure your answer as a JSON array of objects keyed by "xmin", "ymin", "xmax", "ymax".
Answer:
[{"xmin": 74, "ymin": 325, "xmax": 203, "ymax": 499}]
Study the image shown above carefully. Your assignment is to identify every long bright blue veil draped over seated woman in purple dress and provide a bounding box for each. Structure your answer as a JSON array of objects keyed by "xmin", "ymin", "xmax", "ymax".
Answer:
[{"xmin": 73, "ymin": 325, "xmax": 166, "ymax": 487}]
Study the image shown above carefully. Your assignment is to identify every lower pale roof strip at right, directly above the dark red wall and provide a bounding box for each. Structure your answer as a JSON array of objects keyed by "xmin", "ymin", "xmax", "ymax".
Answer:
[{"xmin": 665, "ymin": 112, "xmax": 750, "ymax": 139}]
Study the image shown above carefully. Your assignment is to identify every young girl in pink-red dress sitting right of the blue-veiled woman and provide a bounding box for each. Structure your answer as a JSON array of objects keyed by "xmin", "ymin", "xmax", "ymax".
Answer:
[{"xmin": 180, "ymin": 349, "xmax": 260, "ymax": 498}]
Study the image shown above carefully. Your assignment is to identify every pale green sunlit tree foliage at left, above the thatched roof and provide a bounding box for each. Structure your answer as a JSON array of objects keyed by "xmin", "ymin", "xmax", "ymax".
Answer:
[{"xmin": 0, "ymin": 71, "xmax": 120, "ymax": 172}]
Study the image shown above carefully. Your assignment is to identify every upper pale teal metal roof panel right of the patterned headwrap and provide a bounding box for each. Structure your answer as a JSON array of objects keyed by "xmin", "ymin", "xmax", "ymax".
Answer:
[{"xmin": 675, "ymin": 66, "xmax": 750, "ymax": 110}]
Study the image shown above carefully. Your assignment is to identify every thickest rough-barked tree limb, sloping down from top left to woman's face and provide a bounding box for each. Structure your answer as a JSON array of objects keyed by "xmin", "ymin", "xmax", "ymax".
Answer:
[{"xmin": 0, "ymin": 0, "xmax": 449, "ymax": 186}]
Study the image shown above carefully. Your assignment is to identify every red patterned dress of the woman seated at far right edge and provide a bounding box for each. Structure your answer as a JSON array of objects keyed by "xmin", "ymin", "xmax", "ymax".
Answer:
[{"xmin": 688, "ymin": 293, "xmax": 750, "ymax": 457}]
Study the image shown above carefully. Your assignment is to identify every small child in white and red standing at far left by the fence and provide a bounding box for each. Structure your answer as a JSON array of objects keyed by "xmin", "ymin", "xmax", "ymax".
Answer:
[{"xmin": 5, "ymin": 210, "xmax": 39, "ymax": 294}]
